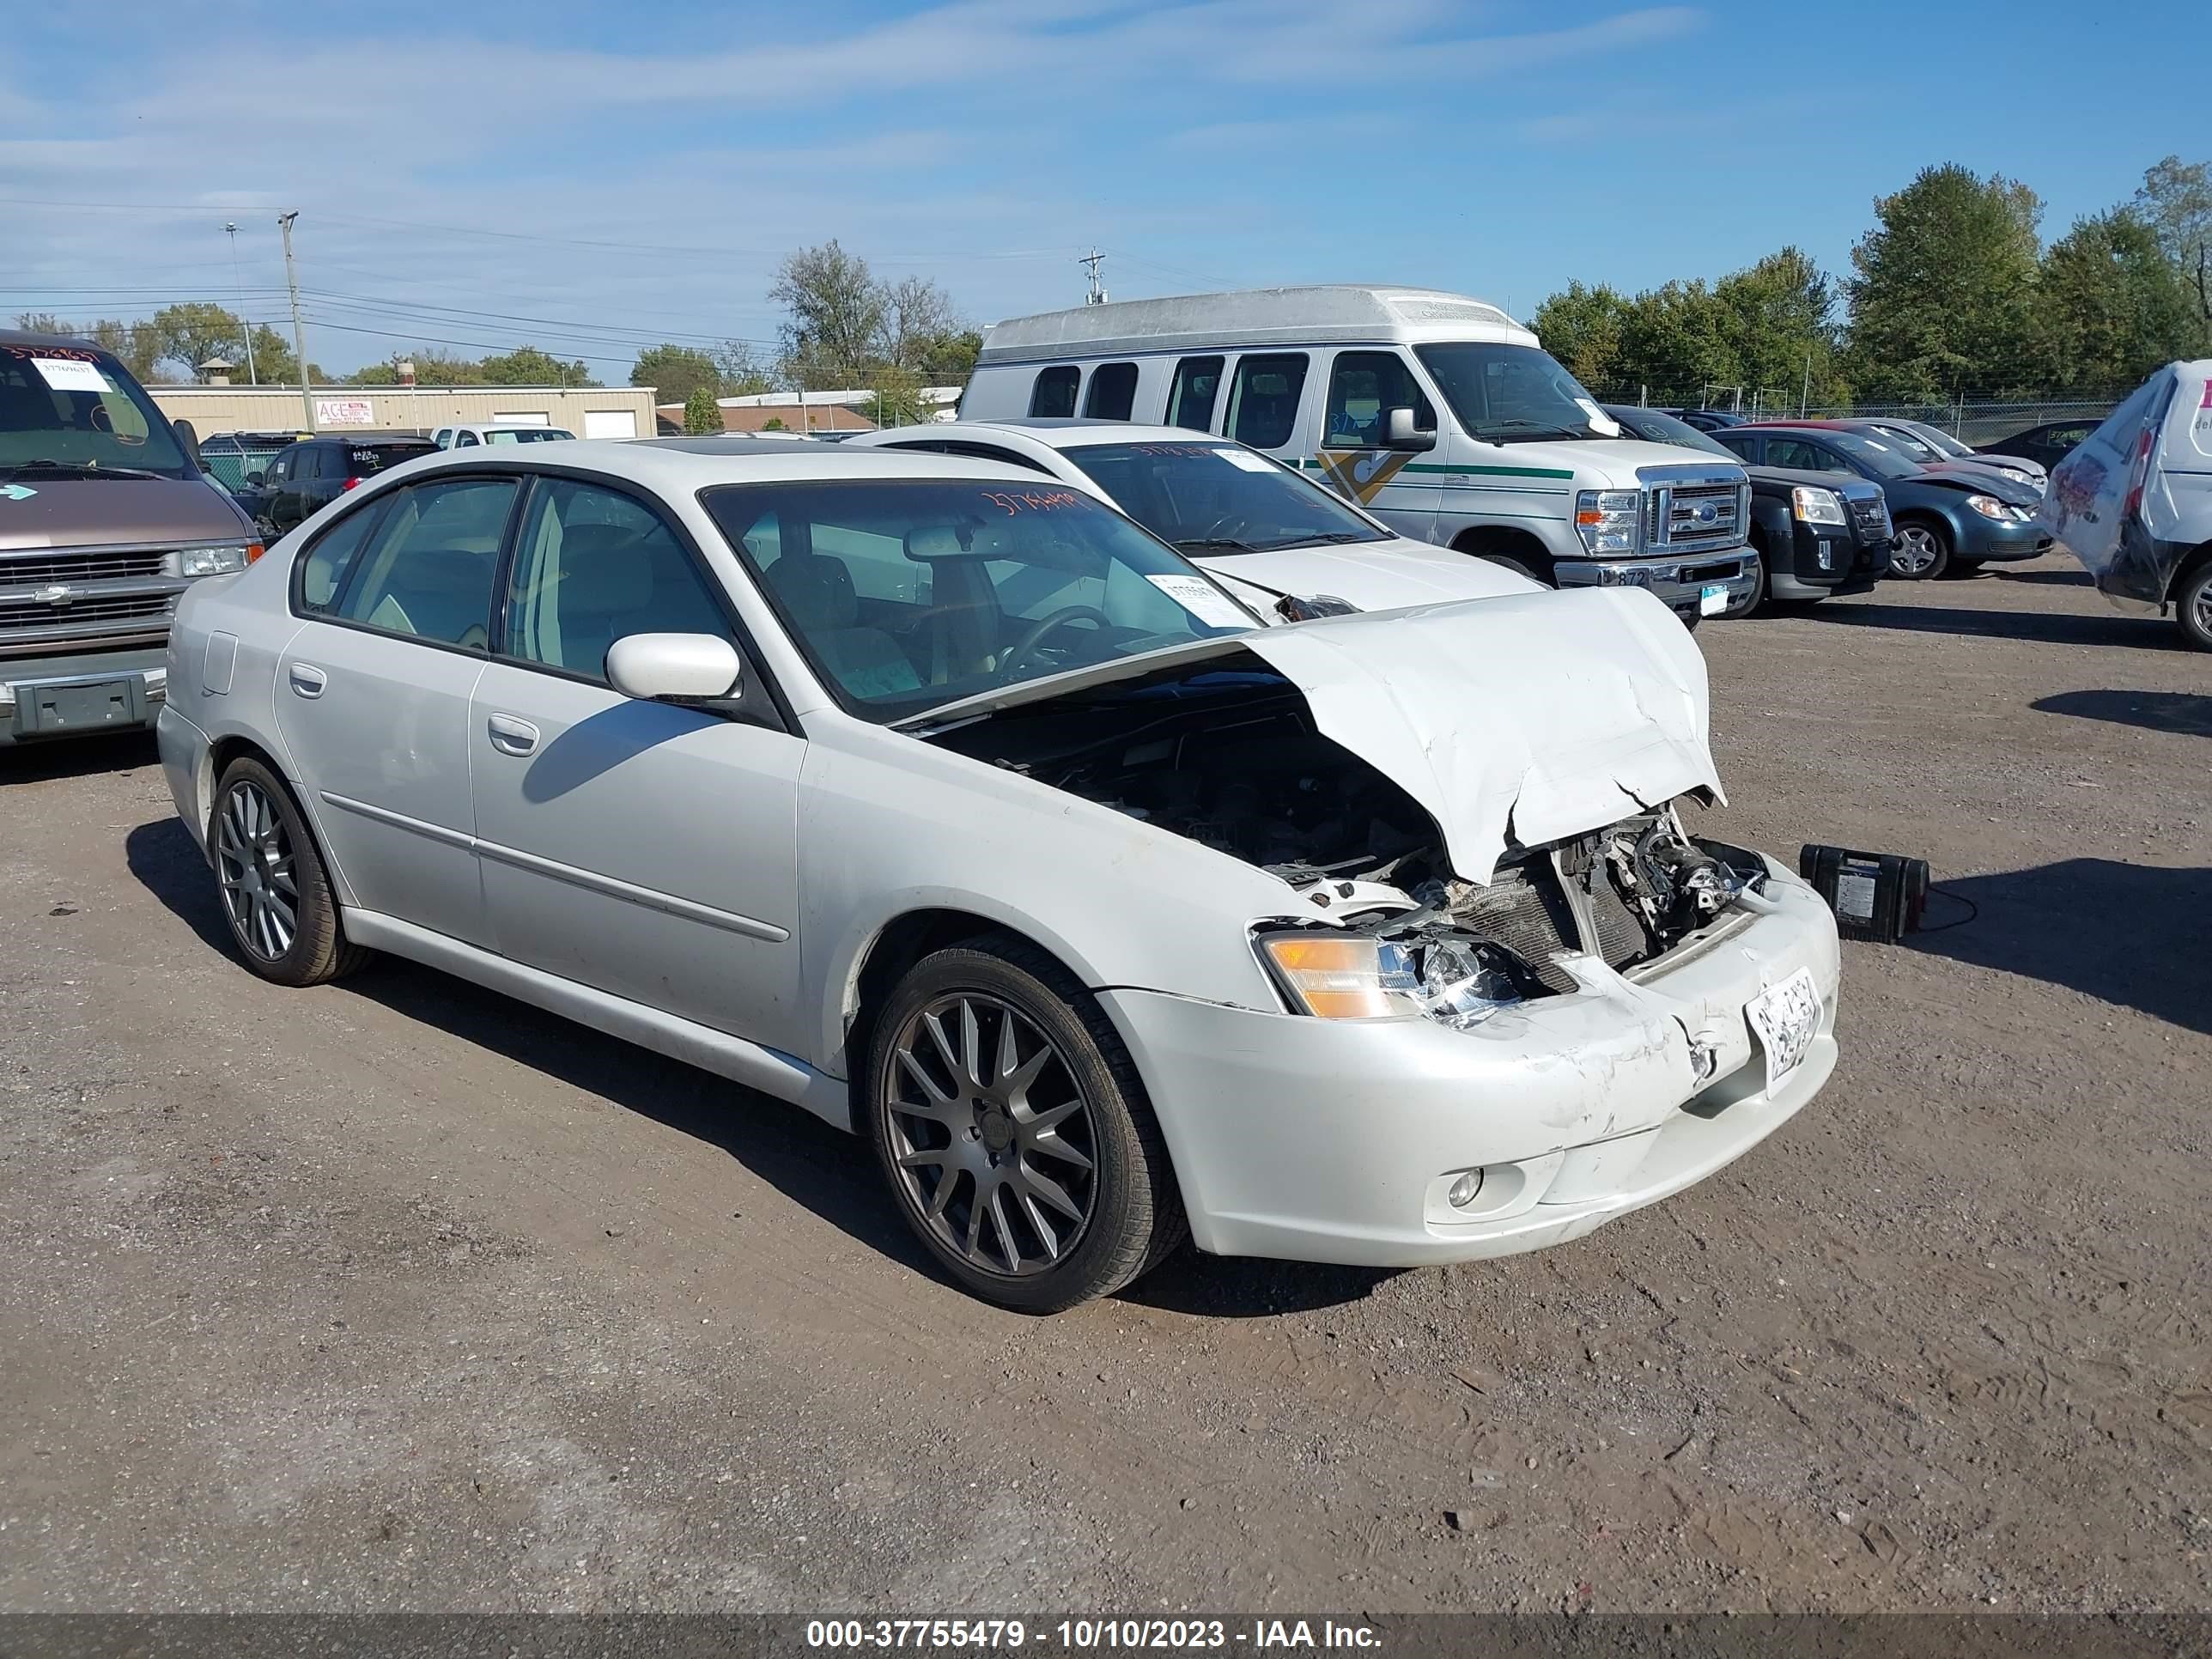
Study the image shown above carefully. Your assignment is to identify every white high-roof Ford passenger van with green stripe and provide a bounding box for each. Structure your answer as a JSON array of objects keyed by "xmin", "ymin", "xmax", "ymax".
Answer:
[{"xmin": 960, "ymin": 288, "xmax": 1759, "ymax": 623}]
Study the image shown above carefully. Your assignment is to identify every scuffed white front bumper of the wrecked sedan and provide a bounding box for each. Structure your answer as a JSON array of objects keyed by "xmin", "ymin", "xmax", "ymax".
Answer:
[{"xmin": 1099, "ymin": 860, "xmax": 1838, "ymax": 1267}]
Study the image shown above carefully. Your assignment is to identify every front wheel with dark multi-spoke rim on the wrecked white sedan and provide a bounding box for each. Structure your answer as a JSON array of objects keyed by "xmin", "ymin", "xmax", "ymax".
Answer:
[{"xmin": 856, "ymin": 936, "xmax": 1188, "ymax": 1314}]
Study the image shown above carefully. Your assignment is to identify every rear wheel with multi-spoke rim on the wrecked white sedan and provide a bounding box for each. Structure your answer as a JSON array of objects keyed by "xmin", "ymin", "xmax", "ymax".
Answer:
[{"xmin": 208, "ymin": 757, "xmax": 369, "ymax": 984}]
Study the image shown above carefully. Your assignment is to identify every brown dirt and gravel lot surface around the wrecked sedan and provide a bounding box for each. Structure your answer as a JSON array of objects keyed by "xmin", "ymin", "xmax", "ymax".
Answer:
[{"xmin": 0, "ymin": 560, "xmax": 2212, "ymax": 1613}]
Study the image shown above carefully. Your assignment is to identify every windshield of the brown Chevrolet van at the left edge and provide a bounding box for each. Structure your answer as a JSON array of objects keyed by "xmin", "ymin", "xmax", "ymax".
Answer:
[{"xmin": 0, "ymin": 345, "xmax": 197, "ymax": 480}]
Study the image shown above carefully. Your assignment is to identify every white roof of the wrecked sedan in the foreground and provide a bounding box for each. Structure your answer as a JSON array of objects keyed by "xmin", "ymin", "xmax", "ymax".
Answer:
[{"xmin": 383, "ymin": 438, "xmax": 1066, "ymax": 495}]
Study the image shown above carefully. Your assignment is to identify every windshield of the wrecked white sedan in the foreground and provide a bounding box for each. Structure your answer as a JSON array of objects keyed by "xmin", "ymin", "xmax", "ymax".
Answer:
[{"xmin": 702, "ymin": 477, "xmax": 1256, "ymax": 721}]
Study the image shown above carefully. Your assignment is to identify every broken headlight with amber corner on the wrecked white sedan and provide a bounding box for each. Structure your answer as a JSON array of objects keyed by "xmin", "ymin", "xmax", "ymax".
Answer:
[{"xmin": 1259, "ymin": 929, "xmax": 1531, "ymax": 1030}]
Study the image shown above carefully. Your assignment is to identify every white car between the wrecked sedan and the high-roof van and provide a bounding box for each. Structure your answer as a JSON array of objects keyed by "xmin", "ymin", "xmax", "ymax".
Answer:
[{"xmin": 848, "ymin": 418, "xmax": 1541, "ymax": 622}]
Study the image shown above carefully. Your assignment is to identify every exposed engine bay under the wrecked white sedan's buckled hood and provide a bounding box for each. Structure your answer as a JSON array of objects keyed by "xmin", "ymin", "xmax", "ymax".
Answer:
[{"xmin": 931, "ymin": 668, "xmax": 1765, "ymax": 1024}]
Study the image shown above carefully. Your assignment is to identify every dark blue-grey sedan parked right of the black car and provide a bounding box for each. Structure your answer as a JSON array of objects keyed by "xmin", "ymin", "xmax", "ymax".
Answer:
[{"xmin": 1714, "ymin": 425, "xmax": 2051, "ymax": 581}]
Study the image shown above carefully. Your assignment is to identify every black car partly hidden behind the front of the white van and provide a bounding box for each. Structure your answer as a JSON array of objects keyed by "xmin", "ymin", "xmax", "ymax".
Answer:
[{"xmin": 1606, "ymin": 403, "xmax": 1891, "ymax": 617}]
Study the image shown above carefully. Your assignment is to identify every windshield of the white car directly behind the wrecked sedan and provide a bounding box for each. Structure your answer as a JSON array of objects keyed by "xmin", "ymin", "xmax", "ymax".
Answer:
[{"xmin": 1061, "ymin": 442, "xmax": 1389, "ymax": 556}]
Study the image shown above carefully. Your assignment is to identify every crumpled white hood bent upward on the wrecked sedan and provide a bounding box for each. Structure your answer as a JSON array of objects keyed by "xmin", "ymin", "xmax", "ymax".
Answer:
[{"xmin": 1243, "ymin": 588, "xmax": 1725, "ymax": 883}]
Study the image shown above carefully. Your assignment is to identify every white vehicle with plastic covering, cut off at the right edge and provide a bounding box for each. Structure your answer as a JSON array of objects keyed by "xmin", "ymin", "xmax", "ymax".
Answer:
[{"xmin": 2042, "ymin": 358, "xmax": 2212, "ymax": 650}]
